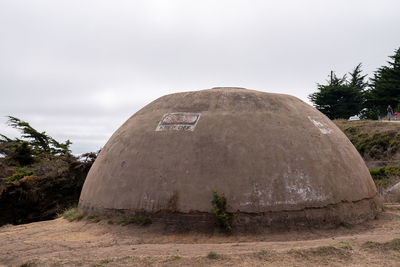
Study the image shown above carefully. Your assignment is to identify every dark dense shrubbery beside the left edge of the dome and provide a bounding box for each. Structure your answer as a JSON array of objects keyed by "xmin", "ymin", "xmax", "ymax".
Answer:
[{"xmin": 0, "ymin": 133, "xmax": 96, "ymax": 225}]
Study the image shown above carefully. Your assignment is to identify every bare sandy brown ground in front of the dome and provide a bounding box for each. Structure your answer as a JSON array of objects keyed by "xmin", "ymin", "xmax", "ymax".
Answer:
[{"xmin": 0, "ymin": 204, "xmax": 400, "ymax": 266}]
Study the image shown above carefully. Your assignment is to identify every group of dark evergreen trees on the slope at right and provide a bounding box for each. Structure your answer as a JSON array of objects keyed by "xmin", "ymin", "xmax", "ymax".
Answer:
[{"xmin": 308, "ymin": 48, "xmax": 400, "ymax": 119}]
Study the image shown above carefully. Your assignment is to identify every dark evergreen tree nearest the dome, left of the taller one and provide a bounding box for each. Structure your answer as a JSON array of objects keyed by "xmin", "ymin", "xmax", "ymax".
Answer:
[{"xmin": 309, "ymin": 63, "xmax": 367, "ymax": 119}]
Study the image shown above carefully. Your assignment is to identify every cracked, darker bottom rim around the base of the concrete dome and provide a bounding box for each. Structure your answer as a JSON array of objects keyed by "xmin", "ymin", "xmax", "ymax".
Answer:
[{"xmin": 78, "ymin": 197, "xmax": 381, "ymax": 231}]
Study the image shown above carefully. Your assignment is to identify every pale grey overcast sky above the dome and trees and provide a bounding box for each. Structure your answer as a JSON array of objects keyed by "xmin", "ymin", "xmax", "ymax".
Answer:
[{"xmin": 0, "ymin": 0, "xmax": 400, "ymax": 153}]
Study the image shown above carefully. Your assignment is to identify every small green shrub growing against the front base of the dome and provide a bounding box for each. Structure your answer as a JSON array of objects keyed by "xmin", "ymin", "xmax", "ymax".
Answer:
[{"xmin": 211, "ymin": 190, "xmax": 233, "ymax": 233}]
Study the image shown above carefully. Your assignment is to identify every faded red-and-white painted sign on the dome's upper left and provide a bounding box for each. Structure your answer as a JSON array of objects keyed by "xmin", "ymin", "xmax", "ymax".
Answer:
[{"xmin": 156, "ymin": 112, "xmax": 200, "ymax": 131}]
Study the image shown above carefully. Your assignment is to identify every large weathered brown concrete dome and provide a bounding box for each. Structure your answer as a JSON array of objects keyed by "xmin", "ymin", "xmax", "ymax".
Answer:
[{"xmin": 79, "ymin": 88, "xmax": 378, "ymax": 228}]
